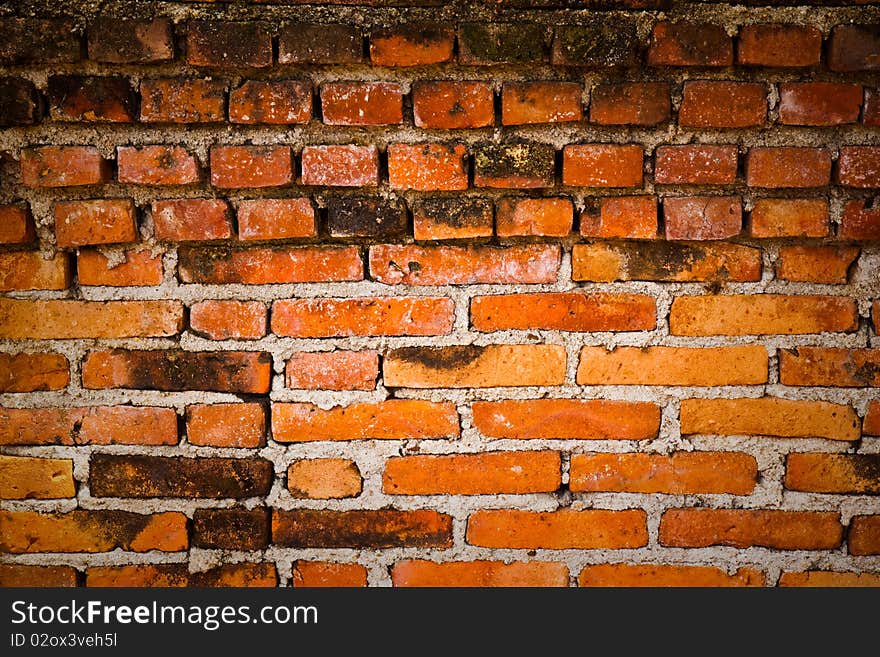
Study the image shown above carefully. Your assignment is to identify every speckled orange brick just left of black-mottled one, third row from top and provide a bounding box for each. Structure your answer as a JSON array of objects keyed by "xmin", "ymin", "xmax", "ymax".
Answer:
[{"xmin": 388, "ymin": 144, "xmax": 468, "ymax": 192}]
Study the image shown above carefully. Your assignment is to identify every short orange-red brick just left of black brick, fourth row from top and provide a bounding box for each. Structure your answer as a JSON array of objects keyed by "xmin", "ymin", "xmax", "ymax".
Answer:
[{"xmin": 238, "ymin": 197, "xmax": 317, "ymax": 241}]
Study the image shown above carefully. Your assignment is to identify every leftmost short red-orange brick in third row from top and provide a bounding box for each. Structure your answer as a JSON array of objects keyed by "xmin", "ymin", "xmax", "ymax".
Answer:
[{"xmin": 21, "ymin": 146, "xmax": 110, "ymax": 187}]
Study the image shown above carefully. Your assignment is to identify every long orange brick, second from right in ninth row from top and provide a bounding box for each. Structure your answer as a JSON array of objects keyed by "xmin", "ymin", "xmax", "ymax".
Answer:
[{"xmin": 569, "ymin": 452, "xmax": 758, "ymax": 495}]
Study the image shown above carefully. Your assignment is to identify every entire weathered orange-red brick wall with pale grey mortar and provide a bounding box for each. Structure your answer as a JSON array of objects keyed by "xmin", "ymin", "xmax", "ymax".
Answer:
[{"xmin": 0, "ymin": 0, "xmax": 880, "ymax": 586}]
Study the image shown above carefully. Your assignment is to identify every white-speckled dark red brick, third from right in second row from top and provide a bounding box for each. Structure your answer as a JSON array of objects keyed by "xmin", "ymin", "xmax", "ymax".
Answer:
[{"xmin": 678, "ymin": 80, "xmax": 767, "ymax": 128}]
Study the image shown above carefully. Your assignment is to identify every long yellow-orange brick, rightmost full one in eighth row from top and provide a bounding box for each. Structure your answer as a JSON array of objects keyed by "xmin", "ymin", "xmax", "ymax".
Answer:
[{"xmin": 681, "ymin": 397, "xmax": 860, "ymax": 440}]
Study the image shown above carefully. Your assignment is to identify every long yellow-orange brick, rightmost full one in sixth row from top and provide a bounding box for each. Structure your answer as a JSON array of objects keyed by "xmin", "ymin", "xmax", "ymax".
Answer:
[{"xmin": 669, "ymin": 294, "xmax": 859, "ymax": 335}]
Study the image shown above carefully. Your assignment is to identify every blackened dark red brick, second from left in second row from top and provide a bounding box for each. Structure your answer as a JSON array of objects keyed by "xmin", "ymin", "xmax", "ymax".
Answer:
[{"xmin": 46, "ymin": 75, "xmax": 137, "ymax": 123}]
